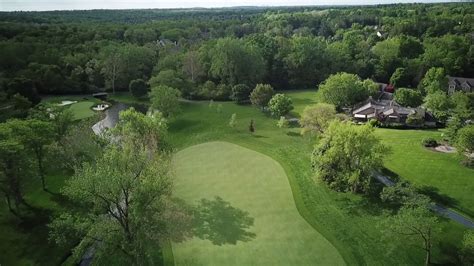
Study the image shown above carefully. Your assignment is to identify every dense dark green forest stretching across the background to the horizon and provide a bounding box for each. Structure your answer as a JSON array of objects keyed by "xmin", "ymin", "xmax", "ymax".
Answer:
[{"xmin": 0, "ymin": 3, "xmax": 474, "ymax": 119}]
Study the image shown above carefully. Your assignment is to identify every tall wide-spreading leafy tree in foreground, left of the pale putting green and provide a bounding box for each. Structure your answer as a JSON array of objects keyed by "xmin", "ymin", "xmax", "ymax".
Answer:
[{"xmin": 50, "ymin": 142, "xmax": 189, "ymax": 265}]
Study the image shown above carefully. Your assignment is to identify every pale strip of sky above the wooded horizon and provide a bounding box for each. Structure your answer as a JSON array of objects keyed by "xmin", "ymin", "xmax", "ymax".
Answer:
[{"xmin": 0, "ymin": 0, "xmax": 460, "ymax": 11}]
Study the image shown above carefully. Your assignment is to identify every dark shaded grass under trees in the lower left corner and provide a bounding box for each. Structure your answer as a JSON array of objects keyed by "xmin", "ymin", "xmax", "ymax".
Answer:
[{"xmin": 0, "ymin": 171, "xmax": 75, "ymax": 265}]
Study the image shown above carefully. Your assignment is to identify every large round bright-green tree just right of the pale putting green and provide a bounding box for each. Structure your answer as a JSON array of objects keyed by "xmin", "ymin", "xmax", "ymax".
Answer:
[{"xmin": 312, "ymin": 120, "xmax": 387, "ymax": 193}]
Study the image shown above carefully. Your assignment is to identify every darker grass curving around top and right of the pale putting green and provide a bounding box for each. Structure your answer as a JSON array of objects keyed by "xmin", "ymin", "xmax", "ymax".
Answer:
[{"xmin": 169, "ymin": 102, "xmax": 465, "ymax": 265}]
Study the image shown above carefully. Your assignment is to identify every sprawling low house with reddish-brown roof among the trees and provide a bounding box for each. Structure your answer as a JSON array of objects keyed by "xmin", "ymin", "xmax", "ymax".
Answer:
[{"xmin": 352, "ymin": 97, "xmax": 436, "ymax": 127}]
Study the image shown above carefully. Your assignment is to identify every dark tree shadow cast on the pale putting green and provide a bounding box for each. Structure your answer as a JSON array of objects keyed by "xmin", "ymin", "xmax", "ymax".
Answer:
[{"xmin": 194, "ymin": 197, "xmax": 256, "ymax": 246}]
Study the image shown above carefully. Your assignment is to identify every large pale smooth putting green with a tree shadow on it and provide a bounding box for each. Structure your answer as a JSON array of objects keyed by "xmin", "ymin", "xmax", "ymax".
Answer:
[{"xmin": 172, "ymin": 142, "xmax": 344, "ymax": 265}]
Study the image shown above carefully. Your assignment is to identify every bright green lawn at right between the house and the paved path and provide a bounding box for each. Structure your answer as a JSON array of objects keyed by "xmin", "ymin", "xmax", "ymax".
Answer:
[{"xmin": 376, "ymin": 129, "xmax": 474, "ymax": 217}]
